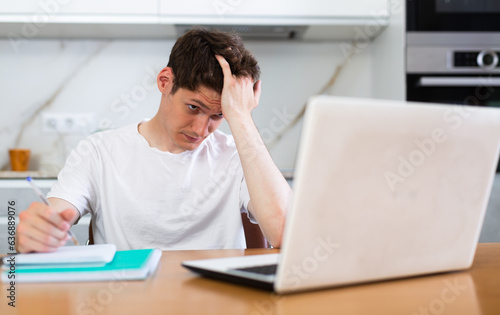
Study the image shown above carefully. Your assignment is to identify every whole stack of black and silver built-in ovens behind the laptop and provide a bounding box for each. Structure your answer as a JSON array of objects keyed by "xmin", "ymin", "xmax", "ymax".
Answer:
[{"xmin": 406, "ymin": 0, "xmax": 500, "ymax": 172}]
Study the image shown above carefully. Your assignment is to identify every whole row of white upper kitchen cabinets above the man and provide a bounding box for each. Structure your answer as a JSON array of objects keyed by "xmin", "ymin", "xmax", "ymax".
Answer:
[{"xmin": 0, "ymin": 0, "xmax": 390, "ymax": 40}]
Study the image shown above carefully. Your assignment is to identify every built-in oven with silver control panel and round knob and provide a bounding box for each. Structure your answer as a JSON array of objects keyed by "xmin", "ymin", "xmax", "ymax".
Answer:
[{"xmin": 406, "ymin": 33, "xmax": 500, "ymax": 107}]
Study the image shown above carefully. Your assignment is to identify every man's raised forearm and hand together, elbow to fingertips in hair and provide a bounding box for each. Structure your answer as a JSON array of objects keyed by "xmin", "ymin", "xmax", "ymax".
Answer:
[{"xmin": 215, "ymin": 55, "xmax": 292, "ymax": 247}]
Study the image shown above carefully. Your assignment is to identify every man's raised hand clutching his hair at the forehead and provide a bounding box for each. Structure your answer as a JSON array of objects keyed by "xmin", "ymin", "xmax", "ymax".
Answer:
[{"xmin": 215, "ymin": 55, "xmax": 261, "ymax": 123}]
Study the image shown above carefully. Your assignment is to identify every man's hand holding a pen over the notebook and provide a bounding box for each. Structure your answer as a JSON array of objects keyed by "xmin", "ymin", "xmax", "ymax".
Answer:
[{"xmin": 16, "ymin": 203, "xmax": 71, "ymax": 253}]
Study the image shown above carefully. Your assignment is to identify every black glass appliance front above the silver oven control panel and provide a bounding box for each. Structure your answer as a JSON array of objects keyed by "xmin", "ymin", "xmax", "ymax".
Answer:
[{"xmin": 406, "ymin": 0, "xmax": 500, "ymax": 32}]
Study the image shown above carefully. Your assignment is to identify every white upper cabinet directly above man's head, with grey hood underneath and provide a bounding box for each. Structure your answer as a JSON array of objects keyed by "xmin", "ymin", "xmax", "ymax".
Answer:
[{"xmin": 160, "ymin": 0, "xmax": 390, "ymax": 41}]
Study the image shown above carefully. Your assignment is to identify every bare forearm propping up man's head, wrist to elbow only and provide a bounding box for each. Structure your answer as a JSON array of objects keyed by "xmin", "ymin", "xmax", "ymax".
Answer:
[{"xmin": 229, "ymin": 117, "xmax": 292, "ymax": 247}]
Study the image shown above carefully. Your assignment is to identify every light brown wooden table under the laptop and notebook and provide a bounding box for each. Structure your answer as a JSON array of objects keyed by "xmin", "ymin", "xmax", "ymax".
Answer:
[{"xmin": 0, "ymin": 243, "xmax": 500, "ymax": 315}]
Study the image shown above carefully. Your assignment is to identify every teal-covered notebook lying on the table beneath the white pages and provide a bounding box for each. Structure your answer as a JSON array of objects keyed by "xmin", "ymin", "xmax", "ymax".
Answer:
[{"xmin": 2, "ymin": 249, "xmax": 161, "ymax": 282}]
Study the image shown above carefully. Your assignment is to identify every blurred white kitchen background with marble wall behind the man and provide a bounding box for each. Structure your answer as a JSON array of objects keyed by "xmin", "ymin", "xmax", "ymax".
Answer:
[{"xmin": 0, "ymin": 0, "xmax": 500, "ymax": 253}]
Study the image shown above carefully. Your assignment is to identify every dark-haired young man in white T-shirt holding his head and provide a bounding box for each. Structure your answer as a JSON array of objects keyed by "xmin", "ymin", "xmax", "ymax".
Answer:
[{"xmin": 16, "ymin": 29, "xmax": 292, "ymax": 252}]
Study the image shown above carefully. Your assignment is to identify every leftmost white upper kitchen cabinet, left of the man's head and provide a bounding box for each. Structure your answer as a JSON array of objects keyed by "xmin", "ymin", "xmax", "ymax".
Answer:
[{"xmin": 0, "ymin": 0, "xmax": 164, "ymax": 39}]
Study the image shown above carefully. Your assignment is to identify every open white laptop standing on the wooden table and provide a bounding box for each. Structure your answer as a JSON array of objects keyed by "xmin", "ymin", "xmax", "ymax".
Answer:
[{"xmin": 182, "ymin": 96, "xmax": 500, "ymax": 294}]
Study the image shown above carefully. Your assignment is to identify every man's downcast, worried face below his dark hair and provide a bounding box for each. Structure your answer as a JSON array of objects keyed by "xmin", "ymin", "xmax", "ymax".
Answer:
[{"xmin": 160, "ymin": 86, "xmax": 224, "ymax": 153}]
